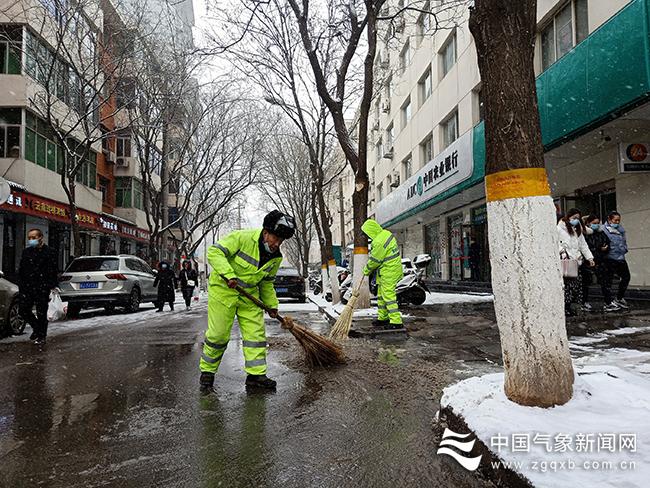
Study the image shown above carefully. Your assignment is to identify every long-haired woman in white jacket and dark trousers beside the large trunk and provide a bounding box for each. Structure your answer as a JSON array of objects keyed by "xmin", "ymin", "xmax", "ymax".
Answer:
[{"xmin": 557, "ymin": 208, "xmax": 596, "ymax": 316}]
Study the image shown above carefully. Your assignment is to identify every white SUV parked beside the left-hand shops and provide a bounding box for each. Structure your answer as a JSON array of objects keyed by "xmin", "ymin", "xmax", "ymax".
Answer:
[{"xmin": 59, "ymin": 255, "xmax": 157, "ymax": 318}]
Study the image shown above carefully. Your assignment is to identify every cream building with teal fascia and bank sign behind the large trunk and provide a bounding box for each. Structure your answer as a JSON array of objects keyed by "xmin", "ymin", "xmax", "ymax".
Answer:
[{"xmin": 346, "ymin": 0, "xmax": 650, "ymax": 286}]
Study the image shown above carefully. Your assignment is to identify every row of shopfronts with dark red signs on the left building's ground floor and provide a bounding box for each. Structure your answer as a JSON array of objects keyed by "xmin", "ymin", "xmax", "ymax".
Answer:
[{"xmin": 0, "ymin": 190, "xmax": 149, "ymax": 281}]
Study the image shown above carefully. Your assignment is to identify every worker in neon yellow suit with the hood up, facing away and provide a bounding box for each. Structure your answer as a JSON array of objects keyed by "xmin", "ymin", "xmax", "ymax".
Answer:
[{"xmin": 361, "ymin": 219, "xmax": 404, "ymax": 329}]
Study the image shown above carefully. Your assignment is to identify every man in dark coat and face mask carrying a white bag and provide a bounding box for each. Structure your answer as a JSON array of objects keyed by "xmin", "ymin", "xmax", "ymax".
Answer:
[{"xmin": 18, "ymin": 229, "xmax": 58, "ymax": 345}]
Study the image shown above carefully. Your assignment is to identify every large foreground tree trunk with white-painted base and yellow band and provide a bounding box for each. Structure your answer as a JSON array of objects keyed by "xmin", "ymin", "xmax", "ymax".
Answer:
[{"xmin": 469, "ymin": 0, "xmax": 574, "ymax": 407}]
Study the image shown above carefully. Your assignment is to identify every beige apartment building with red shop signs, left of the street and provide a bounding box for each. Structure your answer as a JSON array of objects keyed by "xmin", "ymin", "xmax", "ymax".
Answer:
[{"xmin": 0, "ymin": 0, "xmax": 193, "ymax": 279}]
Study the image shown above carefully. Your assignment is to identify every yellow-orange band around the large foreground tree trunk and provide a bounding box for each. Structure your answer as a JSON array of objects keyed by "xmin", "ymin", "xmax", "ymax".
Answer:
[{"xmin": 485, "ymin": 168, "xmax": 551, "ymax": 202}]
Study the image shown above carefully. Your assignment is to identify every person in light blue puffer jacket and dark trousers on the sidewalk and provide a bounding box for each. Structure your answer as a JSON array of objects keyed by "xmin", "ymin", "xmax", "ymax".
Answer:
[{"xmin": 603, "ymin": 211, "xmax": 630, "ymax": 312}]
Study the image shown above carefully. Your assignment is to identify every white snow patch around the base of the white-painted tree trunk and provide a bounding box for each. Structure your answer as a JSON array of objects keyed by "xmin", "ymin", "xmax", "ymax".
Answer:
[{"xmin": 441, "ymin": 356, "xmax": 650, "ymax": 488}]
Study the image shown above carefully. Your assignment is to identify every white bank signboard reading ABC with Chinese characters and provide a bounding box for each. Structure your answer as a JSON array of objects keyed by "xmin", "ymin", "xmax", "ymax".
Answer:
[{"xmin": 376, "ymin": 130, "xmax": 474, "ymax": 224}]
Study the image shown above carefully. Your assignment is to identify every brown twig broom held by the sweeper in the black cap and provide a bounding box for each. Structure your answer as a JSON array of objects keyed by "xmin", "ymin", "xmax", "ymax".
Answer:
[{"xmin": 221, "ymin": 275, "xmax": 345, "ymax": 367}]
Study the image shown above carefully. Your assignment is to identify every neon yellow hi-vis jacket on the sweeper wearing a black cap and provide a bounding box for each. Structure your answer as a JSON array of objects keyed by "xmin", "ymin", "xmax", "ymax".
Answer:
[{"xmin": 208, "ymin": 229, "xmax": 282, "ymax": 308}]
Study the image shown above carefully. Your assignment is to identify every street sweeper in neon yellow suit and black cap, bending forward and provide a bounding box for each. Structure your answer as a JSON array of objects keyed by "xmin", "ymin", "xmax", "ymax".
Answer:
[{"xmin": 199, "ymin": 210, "xmax": 295, "ymax": 393}]
